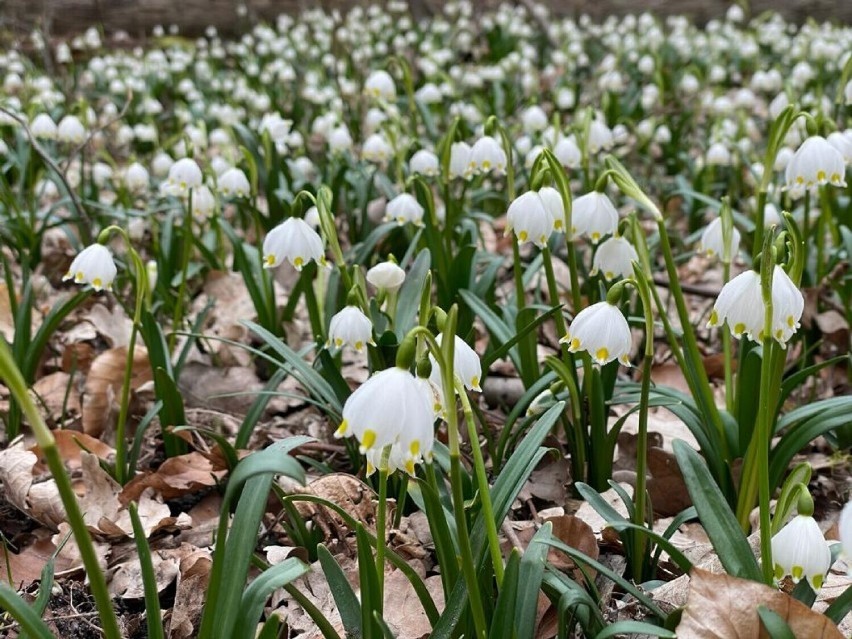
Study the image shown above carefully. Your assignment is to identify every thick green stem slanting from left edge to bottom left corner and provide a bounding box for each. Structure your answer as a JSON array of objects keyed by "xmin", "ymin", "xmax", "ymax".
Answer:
[{"xmin": 0, "ymin": 339, "xmax": 122, "ymax": 639}]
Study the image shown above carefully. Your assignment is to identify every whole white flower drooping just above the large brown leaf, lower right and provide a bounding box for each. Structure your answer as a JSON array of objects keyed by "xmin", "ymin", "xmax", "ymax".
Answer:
[{"xmin": 772, "ymin": 515, "xmax": 831, "ymax": 590}]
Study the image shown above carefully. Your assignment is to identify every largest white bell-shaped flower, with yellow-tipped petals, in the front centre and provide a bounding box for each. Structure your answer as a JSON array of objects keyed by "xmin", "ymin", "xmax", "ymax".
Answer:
[{"xmin": 334, "ymin": 366, "xmax": 434, "ymax": 463}]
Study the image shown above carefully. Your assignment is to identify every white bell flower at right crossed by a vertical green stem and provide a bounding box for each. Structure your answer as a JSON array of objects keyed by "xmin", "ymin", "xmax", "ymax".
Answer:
[{"xmin": 707, "ymin": 266, "xmax": 805, "ymax": 346}]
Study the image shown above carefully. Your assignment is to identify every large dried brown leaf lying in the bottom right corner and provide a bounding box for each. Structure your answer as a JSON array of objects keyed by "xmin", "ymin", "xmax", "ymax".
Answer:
[{"xmin": 677, "ymin": 568, "xmax": 842, "ymax": 639}]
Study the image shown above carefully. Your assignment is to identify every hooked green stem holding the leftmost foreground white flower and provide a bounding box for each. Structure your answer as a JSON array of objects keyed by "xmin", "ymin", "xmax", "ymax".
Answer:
[{"xmin": 98, "ymin": 225, "xmax": 149, "ymax": 485}]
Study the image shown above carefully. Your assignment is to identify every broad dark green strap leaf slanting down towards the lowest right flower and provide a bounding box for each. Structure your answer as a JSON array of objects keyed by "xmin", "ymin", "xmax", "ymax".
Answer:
[{"xmin": 674, "ymin": 439, "xmax": 762, "ymax": 581}]
